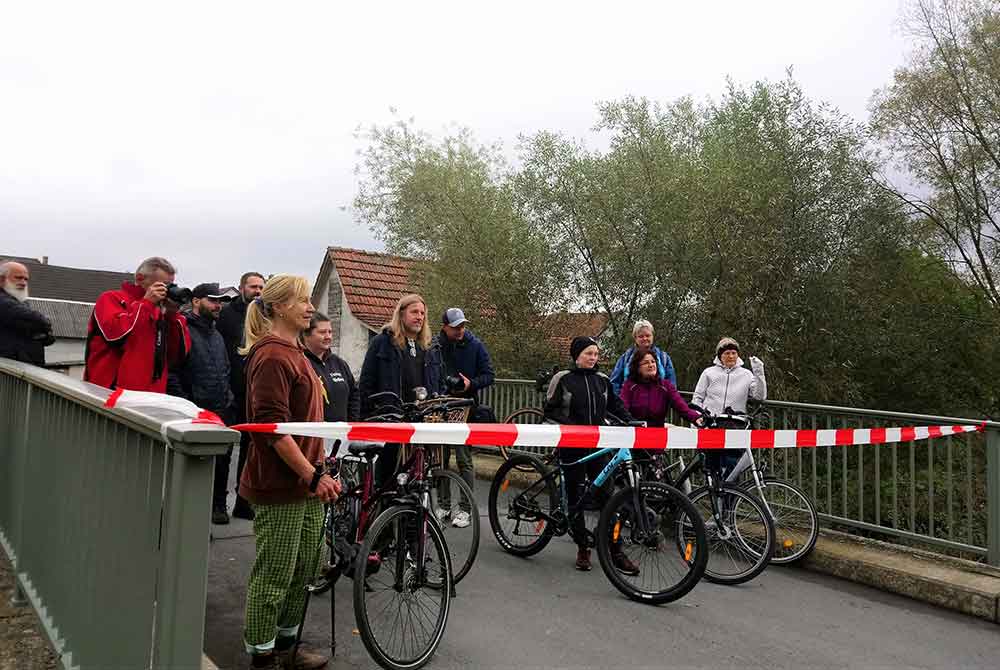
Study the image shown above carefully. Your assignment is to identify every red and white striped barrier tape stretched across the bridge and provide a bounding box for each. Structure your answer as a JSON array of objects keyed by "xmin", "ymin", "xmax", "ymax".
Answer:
[{"xmin": 105, "ymin": 389, "xmax": 984, "ymax": 450}]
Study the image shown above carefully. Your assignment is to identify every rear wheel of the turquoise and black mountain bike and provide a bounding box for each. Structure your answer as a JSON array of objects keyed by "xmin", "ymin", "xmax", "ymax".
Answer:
[{"xmin": 489, "ymin": 454, "xmax": 559, "ymax": 557}]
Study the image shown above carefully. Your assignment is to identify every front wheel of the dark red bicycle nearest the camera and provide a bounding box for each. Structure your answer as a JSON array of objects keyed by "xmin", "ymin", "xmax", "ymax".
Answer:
[{"xmin": 354, "ymin": 505, "xmax": 452, "ymax": 670}]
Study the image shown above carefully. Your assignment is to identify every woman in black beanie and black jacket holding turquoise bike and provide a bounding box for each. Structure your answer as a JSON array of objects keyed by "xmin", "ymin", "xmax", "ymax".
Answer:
[{"xmin": 545, "ymin": 337, "xmax": 639, "ymax": 575}]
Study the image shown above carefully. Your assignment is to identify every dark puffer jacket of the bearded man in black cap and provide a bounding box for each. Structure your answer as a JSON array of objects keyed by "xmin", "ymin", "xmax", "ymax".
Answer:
[{"xmin": 167, "ymin": 313, "xmax": 233, "ymax": 418}]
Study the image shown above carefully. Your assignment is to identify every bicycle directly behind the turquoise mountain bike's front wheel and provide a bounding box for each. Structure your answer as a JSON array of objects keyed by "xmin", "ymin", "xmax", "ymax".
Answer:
[{"xmin": 645, "ymin": 405, "xmax": 775, "ymax": 585}]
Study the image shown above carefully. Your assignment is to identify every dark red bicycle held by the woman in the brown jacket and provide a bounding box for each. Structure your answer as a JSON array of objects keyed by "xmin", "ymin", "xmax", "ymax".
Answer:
[{"xmin": 306, "ymin": 393, "xmax": 478, "ymax": 670}]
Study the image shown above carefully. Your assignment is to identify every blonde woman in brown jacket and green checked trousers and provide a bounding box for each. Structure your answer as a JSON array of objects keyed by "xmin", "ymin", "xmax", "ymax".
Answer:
[{"xmin": 240, "ymin": 275, "xmax": 340, "ymax": 668}]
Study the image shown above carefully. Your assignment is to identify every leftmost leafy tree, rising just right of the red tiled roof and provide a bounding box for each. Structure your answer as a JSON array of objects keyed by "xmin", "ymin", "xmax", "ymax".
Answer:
[{"xmin": 354, "ymin": 117, "xmax": 561, "ymax": 375}]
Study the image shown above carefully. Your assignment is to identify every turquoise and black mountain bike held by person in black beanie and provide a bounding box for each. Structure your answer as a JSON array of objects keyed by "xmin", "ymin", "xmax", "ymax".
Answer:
[{"xmin": 489, "ymin": 418, "xmax": 708, "ymax": 604}]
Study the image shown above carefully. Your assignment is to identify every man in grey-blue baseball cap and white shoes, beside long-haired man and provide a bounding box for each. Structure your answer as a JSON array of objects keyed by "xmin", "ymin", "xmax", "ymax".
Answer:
[{"xmin": 434, "ymin": 307, "xmax": 496, "ymax": 528}]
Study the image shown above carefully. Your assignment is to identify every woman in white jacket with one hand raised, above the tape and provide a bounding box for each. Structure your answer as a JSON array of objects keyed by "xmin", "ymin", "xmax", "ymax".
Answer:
[{"xmin": 692, "ymin": 337, "xmax": 767, "ymax": 414}]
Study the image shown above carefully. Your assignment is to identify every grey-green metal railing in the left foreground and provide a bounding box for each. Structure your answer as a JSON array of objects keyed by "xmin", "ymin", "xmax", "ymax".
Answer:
[{"xmin": 0, "ymin": 360, "xmax": 239, "ymax": 670}]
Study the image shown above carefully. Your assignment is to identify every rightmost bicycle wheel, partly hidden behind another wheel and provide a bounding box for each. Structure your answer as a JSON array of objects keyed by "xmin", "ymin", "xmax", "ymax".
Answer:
[{"xmin": 743, "ymin": 477, "xmax": 819, "ymax": 565}]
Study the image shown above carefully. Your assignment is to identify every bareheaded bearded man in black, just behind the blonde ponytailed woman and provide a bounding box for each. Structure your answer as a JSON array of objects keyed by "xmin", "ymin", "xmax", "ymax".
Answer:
[{"xmin": 217, "ymin": 272, "xmax": 264, "ymax": 521}]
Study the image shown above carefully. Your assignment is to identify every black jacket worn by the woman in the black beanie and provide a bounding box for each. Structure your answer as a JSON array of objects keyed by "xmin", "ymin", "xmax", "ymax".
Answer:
[{"xmin": 545, "ymin": 367, "xmax": 632, "ymax": 426}]
